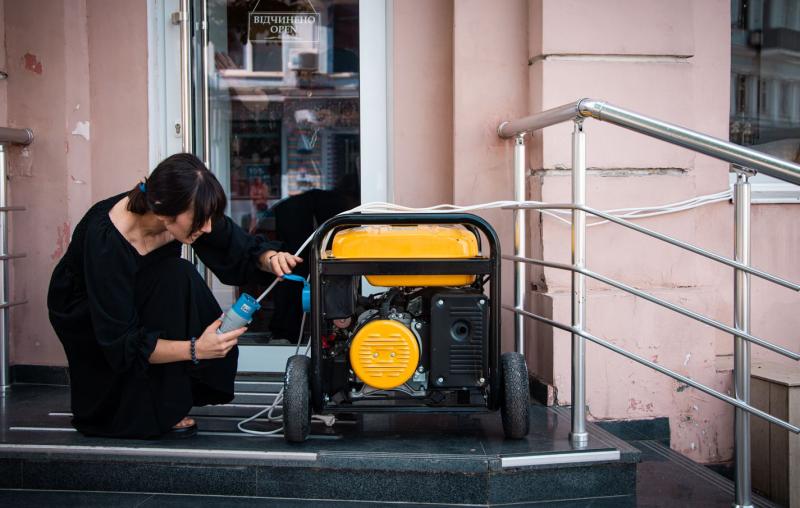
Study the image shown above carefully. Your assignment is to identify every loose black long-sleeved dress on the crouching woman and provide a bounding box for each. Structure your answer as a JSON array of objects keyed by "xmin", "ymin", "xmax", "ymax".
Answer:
[{"xmin": 47, "ymin": 194, "xmax": 279, "ymax": 438}]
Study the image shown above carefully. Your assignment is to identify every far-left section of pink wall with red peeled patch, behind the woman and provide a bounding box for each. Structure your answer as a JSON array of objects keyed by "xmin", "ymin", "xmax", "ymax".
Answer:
[{"xmin": 4, "ymin": 0, "xmax": 71, "ymax": 364}]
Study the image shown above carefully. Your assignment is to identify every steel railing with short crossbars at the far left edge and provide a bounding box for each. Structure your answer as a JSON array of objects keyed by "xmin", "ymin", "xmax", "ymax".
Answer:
[{"xmin": 0, "ymin": 127, "xmax": 33, "ymax": 396}]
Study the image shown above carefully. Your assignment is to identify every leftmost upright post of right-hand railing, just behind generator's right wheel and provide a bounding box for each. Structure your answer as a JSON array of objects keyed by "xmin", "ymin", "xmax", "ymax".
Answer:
[{"xmin": 514, "ymin": 133, "xmax": 527, "ymax": 356}]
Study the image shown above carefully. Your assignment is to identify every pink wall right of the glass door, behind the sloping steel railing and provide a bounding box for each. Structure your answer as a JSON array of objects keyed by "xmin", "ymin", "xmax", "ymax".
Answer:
[{"xmin": 393, "ymin": 0, "xmax": 800, "ymax": 462}]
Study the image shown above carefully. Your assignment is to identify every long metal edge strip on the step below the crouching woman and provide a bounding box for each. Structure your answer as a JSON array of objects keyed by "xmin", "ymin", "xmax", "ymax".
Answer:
[{"xmin": 0, "ymin": 443, "xmax": 317, "ymax": 462}]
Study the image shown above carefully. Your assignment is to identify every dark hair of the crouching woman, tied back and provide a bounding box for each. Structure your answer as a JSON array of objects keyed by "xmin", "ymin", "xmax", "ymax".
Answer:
[{"xmin": 128, "ymin": 153, "xmax": 227, "ymax": 233}]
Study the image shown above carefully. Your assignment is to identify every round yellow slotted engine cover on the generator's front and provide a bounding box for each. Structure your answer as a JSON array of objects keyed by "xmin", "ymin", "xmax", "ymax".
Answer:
[{"xmin": 350, "ymin": 319, "xmax": 419, "ymax": 390}]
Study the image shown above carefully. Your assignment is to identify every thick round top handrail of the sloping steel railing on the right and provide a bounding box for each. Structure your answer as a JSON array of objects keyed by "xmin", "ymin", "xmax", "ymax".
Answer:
[{"xmin": 497, "ymin": 99, "xmax": 800, "ymax": 185}]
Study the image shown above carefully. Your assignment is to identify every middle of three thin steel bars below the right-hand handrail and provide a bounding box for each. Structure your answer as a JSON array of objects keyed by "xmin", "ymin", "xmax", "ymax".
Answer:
[{"xmin": 503, "ymin": 255, "xmax": 800, "ymax": 361}]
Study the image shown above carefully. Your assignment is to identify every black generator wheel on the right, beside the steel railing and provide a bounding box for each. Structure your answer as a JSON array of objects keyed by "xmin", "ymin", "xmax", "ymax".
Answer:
[{"xmin": 500, "ymin": 352, "xmax": 530, "ymax": 439}]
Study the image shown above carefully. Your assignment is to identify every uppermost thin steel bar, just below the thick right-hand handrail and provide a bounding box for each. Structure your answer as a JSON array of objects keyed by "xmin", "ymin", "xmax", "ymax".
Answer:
[{"xmin": 502, "ymin": 203, "xmax": 800, "ymax": 292}]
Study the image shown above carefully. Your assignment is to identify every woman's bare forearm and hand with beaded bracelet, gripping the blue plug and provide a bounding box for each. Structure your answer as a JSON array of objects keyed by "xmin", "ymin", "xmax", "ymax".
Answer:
[{"xmin": 149, "ymin": 319, "xmax": 247, "ymax": 363}]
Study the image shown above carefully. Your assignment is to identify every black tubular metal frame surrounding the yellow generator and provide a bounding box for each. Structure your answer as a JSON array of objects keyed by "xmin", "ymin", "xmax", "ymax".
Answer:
[{"xmin": 309, "ymin": 213, "xmax": 502, "ymax": 413}]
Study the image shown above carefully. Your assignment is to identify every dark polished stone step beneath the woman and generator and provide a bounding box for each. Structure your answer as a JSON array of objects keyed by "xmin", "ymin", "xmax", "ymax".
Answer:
[{"xmin": 0, "ymin": 386, "xmax": 639, "ymax": 506}]
